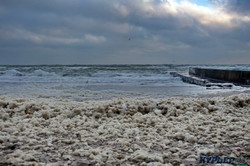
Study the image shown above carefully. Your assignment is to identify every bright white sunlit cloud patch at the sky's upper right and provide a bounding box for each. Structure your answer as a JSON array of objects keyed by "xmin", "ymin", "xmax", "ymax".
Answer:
[{"xmin": 129, "ymin": 0, "xmax": 250, "ymax": 28}]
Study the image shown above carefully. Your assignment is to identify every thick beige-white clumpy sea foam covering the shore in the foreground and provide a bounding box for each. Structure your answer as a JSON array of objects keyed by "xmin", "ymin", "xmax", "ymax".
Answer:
[{"xmin": 0, "ymin": 94, "xmax": 250, "ymax": 165}]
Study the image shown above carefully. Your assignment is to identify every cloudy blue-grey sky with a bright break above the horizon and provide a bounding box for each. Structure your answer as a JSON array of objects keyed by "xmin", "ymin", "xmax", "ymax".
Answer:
[{"xmin": 0, "ymin": 0, "xmax": 250, "ymax": 65}]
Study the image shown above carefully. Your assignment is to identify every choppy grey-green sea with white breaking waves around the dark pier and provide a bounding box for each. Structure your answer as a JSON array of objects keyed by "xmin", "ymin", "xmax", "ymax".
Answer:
[{"xmin": 0, "ymin": 64, "xmax": 250, "ymax": 101}]
